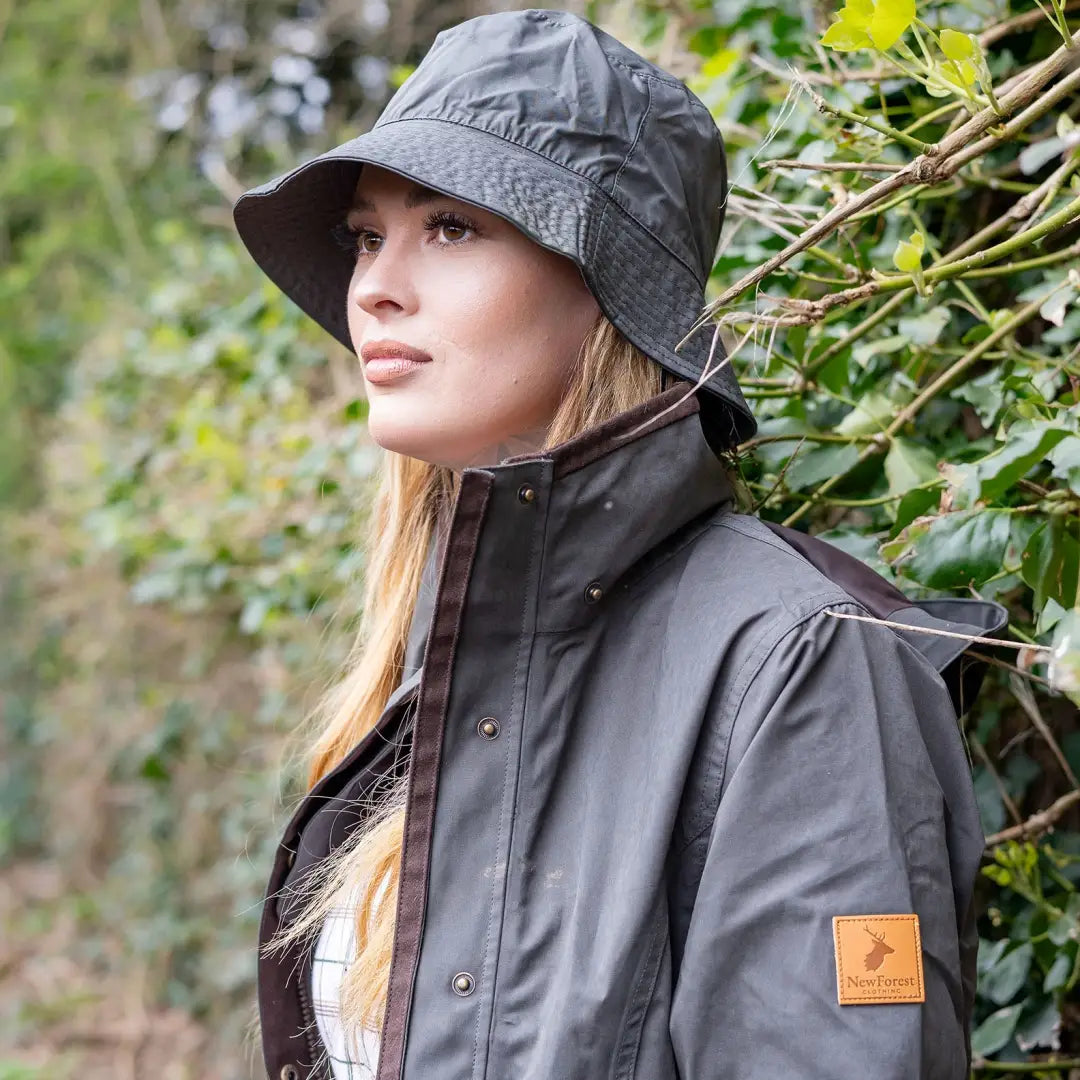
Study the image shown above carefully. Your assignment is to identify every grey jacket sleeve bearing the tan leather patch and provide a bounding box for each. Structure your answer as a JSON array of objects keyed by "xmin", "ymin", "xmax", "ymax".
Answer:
[{"xmin": 670, "ymin": 603, "xmax": 983, "ymax": 1080}]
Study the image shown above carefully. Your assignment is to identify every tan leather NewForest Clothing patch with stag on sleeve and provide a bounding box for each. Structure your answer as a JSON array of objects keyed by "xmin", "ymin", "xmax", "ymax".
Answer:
[{"xmin": 833, "ymin": 915, "xmax": 926, "ymax": 1005}]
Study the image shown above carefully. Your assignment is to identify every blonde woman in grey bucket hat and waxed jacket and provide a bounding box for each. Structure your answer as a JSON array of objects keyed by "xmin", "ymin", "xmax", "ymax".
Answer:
[{"xmin": 235, "ymin": 11, "xmax": 1001, "ymax": 1080}]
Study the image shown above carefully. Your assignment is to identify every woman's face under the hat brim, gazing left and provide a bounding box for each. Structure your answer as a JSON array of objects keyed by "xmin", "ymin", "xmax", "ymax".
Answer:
[{"xmin": 343, "ymin": 165, "xmax": 599, "ymax": 469}]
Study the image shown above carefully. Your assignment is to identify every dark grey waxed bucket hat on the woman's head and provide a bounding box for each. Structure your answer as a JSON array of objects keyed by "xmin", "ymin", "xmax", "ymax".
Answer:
[{"xmin": 233, "ymin": 10, "xmax": 756, "ymax": 447}]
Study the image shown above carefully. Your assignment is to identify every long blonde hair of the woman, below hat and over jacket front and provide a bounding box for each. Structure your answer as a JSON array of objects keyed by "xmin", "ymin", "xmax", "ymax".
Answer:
[{"xmin": 266, "ymin": 315, "xmax": 689, "ymax": 1062}]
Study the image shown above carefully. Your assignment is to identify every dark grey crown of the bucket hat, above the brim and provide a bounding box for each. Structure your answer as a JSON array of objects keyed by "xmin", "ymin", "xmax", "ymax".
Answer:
[{"xmin": 375, "ymin": 10, "xmax": 727, "ymax": 284}]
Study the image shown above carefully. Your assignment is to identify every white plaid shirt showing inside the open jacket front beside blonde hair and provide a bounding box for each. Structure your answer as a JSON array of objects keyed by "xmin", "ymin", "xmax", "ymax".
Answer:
[{"xmin": 311, "ymin": 887, "xmax": 384, "ymax": 1080}]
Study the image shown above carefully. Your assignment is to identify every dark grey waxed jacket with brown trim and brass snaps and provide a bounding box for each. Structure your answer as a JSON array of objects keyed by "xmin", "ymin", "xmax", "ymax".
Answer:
[{"xmin": 258, "ymin": 383, "xmax": 1003, "ymax": 1080}]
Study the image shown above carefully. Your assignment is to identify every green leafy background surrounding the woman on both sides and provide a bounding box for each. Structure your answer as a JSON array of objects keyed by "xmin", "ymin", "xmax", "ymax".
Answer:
[{"xmin": 0, "ymin": 0, "xmax": 1080, "ymax": 1080}]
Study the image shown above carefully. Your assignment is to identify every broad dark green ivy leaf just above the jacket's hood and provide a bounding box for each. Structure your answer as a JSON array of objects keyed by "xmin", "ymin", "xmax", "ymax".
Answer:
[{"xmin": 902, "ymin": 510, "xmax": 1011, "ymax": 589}]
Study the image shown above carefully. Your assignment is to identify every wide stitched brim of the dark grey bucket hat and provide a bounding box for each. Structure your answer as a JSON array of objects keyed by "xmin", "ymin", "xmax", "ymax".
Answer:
[{"xmin": 233, "ymin": 118, "xmax": 756, "ymax": 447}]
